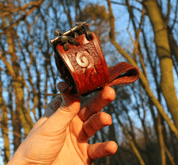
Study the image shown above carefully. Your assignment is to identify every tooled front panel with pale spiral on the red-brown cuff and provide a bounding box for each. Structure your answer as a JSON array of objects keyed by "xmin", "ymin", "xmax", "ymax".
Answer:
[{"xmin": 67, "ymin": 42, "xmax": 105, "ymax": 92}]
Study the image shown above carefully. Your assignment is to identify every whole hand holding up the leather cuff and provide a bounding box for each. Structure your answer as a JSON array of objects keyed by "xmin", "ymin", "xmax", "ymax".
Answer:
[{"xmin": 8, "ymin": 82, "xmax": 117, "ymax": 165}]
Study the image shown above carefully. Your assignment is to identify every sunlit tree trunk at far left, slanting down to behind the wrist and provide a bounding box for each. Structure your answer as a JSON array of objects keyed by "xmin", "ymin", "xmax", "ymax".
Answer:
[{"xmin": 2, "ymin": 9, "xmax": 33, "ymax": 136}]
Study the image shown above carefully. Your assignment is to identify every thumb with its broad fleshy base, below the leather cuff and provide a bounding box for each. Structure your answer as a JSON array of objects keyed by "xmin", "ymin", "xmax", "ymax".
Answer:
[{"xmin": 16, "ymin": 83, "xmax": 80, "ymax": 165}]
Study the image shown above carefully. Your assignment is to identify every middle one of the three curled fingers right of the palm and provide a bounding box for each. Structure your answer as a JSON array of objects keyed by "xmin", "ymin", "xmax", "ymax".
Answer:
[{"xmin": 83, "ymin": 112, "xmax": 112, "ymax": 139}]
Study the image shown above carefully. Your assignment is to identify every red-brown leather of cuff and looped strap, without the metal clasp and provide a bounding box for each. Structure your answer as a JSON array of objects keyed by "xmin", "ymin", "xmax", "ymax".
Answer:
[{"xmin": 56, "ymin": 32, "xmax": 139, "ymax": 95}]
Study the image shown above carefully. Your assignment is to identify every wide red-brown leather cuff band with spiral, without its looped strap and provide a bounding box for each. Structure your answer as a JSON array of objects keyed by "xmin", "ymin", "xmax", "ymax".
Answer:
[{"xmin": 56, "ymin": 32, "xmax": 109, "ymax": 95}]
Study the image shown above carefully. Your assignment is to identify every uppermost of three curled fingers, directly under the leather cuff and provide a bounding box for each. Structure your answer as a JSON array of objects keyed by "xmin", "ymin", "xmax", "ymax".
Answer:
[{"xmin": 78, "ymin": 86, "xmax": 115, "ymax": 121}]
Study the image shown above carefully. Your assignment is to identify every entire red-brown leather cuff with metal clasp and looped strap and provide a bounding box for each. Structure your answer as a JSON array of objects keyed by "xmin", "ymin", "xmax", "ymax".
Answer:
[{"xmin": 50, "ymin": 22, "xmax": 139, "ymax": 96}]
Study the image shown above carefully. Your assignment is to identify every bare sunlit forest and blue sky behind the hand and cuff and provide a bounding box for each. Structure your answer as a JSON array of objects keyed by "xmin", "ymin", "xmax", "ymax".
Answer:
[{"xmin": 0, "ymin": 0, "xmax": 178, "ymax": 165}]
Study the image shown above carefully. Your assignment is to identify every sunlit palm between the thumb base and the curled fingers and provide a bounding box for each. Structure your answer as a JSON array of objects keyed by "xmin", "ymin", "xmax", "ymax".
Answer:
[{"xmin": 53, "ymin": 116, "xmax": 91, "ymax": 165}]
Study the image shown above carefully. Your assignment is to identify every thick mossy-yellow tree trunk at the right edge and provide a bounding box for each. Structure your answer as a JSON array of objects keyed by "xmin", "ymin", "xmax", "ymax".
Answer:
[{"xmin": 144, "ymin": 0, "xmax": 178, "ymax": 128}]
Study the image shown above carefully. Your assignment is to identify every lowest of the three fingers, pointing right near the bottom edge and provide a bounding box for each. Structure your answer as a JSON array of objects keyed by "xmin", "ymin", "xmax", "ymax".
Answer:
[{"xmin": 88, "ymin": 141, "xmax": 118, "ymax": 159}]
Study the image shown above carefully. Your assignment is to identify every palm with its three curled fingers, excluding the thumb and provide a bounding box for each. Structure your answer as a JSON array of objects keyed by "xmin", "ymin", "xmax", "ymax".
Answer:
[{"xmin": 53, "ymin": 86, "xmax": 117, "ymax": 165}]
